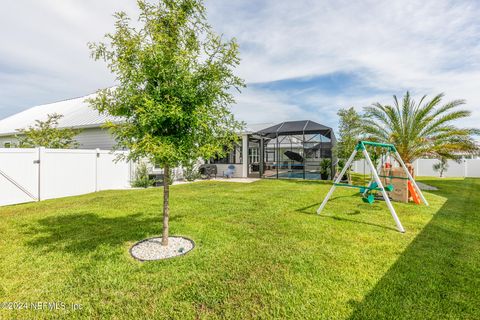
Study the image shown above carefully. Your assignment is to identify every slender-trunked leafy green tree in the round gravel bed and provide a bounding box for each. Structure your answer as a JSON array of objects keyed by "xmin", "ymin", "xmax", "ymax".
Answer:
[{"xmin": 90, "ymin": 0, "xmax": 244, "ymax": 245}]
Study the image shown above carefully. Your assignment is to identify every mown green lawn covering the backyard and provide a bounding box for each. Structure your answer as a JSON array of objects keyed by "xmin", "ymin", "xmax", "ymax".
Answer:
[{"xmin": 0, "ymin": 178, "xmax": 480, "ymax": 319}]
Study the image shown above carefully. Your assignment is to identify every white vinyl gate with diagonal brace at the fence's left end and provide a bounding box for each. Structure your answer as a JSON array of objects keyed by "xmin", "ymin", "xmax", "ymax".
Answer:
[{"xmin": 0, "ymin": 149, "xmax": 39, "ymax": 206}]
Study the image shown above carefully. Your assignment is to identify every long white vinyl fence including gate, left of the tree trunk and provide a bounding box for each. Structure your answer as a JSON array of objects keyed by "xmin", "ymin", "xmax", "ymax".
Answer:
[{"xmin": 0, "ymin": 148, "xmax": 132, "ymax": 206}]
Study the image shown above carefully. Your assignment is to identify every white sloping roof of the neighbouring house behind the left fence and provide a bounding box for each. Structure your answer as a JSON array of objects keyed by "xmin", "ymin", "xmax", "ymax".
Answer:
[{"xmin": 0, "ymin": 94, "xmax": 120, "ymax": 136}]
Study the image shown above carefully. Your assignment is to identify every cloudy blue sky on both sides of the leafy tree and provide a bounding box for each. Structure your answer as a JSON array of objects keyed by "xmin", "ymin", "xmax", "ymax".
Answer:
[{"xmin": 0, "ymin": 0, "xmax": 480, "ymax": 131}]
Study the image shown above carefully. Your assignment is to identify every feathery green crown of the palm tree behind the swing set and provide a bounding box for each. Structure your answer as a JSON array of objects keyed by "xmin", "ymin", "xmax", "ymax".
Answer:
[{"xmin": 363, "ymin": 91, "xmax": 480, "ymax": 163}]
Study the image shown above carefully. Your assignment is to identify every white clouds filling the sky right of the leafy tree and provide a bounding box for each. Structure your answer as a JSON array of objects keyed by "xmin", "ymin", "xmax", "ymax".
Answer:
[{"xmin": 209, "ymin": 0, "xmax": 480, "ymax": 126}]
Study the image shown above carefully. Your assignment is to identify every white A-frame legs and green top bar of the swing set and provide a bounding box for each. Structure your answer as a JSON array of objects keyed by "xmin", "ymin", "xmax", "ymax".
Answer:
[{"xmin": 317, "ymin": 141, "xmax": 428, "ymax": 233}]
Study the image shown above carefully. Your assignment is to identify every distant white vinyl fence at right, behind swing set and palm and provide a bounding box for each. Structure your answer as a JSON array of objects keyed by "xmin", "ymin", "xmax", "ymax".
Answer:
[{"xmin": 352, "ymin": 159, "xmax": 480, "ymax": 178}]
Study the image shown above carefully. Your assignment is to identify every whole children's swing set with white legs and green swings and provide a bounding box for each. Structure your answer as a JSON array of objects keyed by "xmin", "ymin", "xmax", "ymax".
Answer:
[{"xmin": 317, "ymin": 141, "xmax": 428, "ymax": 232}]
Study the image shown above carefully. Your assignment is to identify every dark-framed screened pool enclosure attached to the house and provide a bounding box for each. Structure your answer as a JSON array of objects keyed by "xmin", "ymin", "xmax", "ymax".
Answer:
[{"xmin": 248, "ymin": 120, "xmax": 335, "ymax": 179}]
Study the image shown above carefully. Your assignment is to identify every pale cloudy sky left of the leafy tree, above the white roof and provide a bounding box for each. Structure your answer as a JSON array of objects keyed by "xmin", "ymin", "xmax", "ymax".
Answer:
[{"xmin": 0, "ymin": 0, "xmax": 139, "ymax": 118}]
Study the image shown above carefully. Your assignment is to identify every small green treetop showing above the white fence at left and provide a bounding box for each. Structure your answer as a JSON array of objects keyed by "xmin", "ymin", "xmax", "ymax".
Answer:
[{"xmin": 16, "ymin": 113, "xmax": 81, "ymax": 149}]
